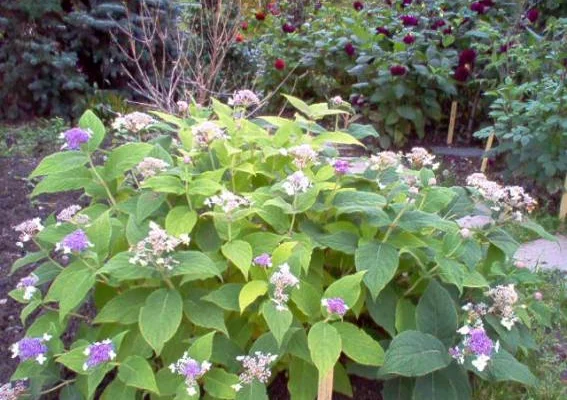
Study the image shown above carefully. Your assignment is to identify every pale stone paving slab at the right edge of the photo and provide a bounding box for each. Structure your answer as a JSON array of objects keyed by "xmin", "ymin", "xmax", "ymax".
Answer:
[{"xmin": 514, "ymin": 235, "xmax": 567, "ymax": 272}]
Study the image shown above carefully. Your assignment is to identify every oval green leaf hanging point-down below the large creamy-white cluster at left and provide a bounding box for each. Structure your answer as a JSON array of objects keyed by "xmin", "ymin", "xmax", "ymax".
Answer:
[{"xmin": 138, "ymin": 289, "xmax": 183, "ymax": 354}]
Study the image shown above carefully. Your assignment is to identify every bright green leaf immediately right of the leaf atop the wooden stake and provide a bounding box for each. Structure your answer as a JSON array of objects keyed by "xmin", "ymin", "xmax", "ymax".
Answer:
[{"xmin": 333, "ymin": 322, "xmax": 384, "ymax": 367}]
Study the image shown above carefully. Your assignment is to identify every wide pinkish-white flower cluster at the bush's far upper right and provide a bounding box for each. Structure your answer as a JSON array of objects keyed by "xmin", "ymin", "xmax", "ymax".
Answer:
[{"xmin": 467, "ymin": 172, "xmax": 537, "ymax": 221}]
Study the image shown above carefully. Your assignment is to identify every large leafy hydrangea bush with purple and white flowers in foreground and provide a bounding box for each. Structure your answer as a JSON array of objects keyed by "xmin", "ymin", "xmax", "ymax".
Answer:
[{"xmin": 6, "ymin": 91, "xmax": 546, "ymax": 400}]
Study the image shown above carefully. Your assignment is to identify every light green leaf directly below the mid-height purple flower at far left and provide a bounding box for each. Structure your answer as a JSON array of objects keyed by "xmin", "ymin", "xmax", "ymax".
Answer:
[{"xmin": 45, "ymin": 261, "xmax": 95, "ymax": 320}]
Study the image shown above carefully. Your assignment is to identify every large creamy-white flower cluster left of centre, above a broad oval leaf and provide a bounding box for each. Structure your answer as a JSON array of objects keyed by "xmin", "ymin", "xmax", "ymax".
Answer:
[{"xmin": 129, "ymin": 221, "xmax": 190, "ymax": 270}]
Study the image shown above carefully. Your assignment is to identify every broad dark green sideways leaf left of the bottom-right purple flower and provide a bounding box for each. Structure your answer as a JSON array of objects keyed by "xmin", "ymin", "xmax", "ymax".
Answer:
[{"xmin": 380, "ymin": 331, "xmax": 451, "ymax": 377}]
